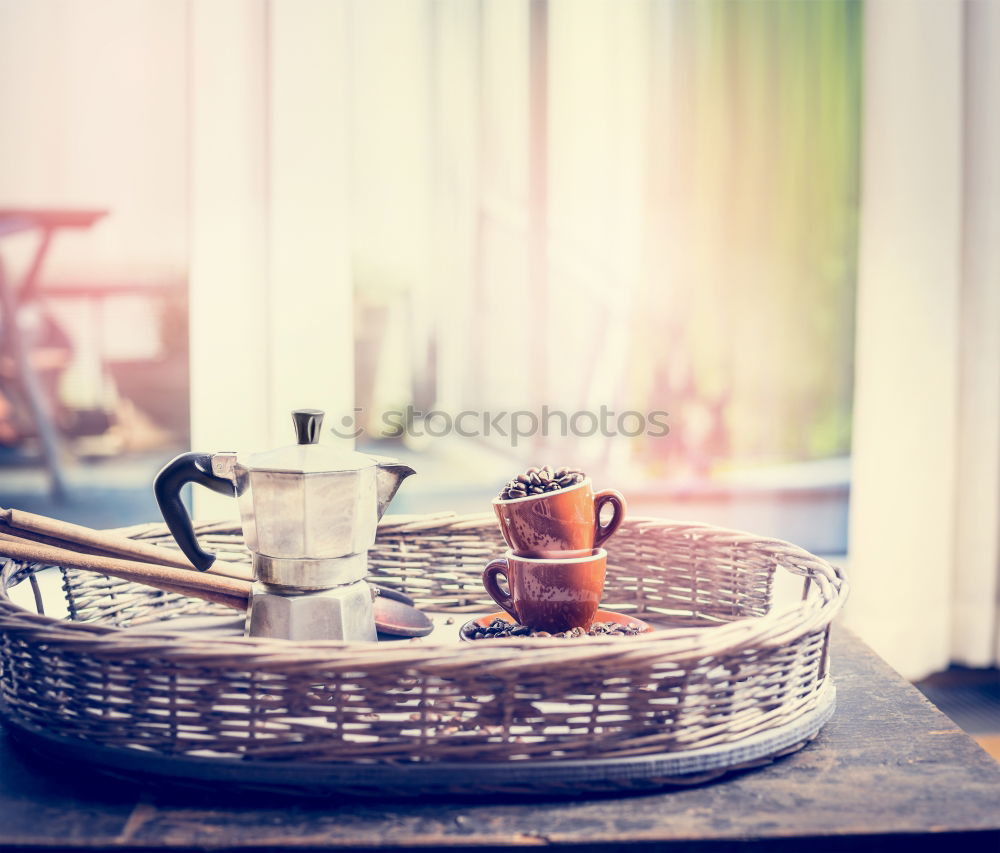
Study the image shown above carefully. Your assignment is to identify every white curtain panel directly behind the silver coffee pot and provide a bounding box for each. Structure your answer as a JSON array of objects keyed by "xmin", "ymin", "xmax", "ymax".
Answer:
[{"xmin": 188, "ymin": 0, "xmax": 354, "ymax": 518}]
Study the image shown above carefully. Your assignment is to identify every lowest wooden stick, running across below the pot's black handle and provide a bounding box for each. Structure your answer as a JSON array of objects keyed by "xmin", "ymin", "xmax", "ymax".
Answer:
[{"xmin": 0, "ymin": 533, "xmax": 250, "ymax": 610}]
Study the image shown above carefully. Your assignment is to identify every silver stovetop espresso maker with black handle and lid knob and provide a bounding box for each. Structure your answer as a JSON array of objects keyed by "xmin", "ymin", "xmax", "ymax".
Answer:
[{"xmin": 154, "ymin": 409, "xmax": 415, "ymax": 640}]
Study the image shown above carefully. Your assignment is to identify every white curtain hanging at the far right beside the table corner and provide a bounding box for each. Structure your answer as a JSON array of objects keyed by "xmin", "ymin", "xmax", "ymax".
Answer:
[{"xmin": 845, "ymin": 0, "xmax": 1000, "ymax": 678}]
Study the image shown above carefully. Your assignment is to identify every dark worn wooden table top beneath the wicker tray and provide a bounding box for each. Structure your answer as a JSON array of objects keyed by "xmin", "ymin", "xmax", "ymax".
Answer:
[{"xmin": 0, "ymin": 631, "xmax": 1000, "ymax": 853}]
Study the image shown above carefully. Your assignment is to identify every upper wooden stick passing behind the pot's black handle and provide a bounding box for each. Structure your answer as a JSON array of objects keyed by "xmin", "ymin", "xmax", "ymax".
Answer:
[{"xmin": 0, "ymin": 509, "xmax": 251, "ymax": 580}]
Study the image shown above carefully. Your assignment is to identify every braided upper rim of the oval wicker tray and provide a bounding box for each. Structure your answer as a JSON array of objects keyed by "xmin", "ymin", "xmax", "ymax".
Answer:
[{"xmin": 0, "ymin": 512, "xmax": 848, "ymax": 675}]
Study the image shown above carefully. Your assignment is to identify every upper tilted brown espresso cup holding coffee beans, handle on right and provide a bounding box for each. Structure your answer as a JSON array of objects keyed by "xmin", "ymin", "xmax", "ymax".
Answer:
[{"xmin": 493, "ymin": 477, "xmax": 625, "ymax": 558}]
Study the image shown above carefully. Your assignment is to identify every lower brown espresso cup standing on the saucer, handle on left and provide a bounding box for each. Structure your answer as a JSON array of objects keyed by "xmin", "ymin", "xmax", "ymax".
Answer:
[{"xmin": 483, "ymin": 548, "xmax": 608, "ymax": 633}]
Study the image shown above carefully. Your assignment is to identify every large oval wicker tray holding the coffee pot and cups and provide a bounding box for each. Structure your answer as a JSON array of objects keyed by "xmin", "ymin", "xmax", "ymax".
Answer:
[{"xmin": 0, "ymin": 515, "xmax": 846, "ymax": 793}]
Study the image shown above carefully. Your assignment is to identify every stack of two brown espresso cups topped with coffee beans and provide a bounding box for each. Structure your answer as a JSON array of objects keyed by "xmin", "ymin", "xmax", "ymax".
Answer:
[{"xmin": 483, "ymin": 468, "xmax": 625, "ymax": 633}]
